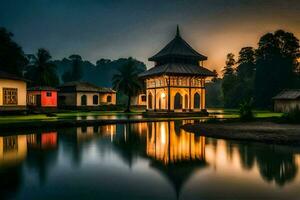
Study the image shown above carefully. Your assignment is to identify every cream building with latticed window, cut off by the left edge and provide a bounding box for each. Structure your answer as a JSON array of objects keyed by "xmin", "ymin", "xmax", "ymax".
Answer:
[{"xmin": 0, "ymin": 71, "xmax": 27, "ymax": 112}]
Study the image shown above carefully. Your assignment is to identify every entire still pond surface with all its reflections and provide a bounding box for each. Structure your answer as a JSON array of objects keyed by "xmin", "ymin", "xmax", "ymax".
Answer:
[{"xmin": 0, "ymin": 122, "xmax": 300, "ymax": 199}]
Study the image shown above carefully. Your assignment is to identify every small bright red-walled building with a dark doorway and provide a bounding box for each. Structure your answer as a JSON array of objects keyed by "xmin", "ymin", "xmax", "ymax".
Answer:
[{"xmin": 27, "ymin": 87, "xmax": 57, "ymax": 108}]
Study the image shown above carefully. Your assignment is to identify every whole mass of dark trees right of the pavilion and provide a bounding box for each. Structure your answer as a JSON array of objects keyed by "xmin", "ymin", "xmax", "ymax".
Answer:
[{"xmin": 207, "ymin": 30, "xmax": 300, "ymax": 108}]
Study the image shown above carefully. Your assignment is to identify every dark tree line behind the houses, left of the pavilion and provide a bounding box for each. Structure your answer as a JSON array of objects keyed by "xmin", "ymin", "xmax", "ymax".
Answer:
[{"xmin": 0, "ymin": 28, "xmax": 146, "ymax": 90}]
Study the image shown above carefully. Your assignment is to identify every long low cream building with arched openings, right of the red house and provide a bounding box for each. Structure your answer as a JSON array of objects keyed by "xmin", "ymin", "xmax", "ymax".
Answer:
[{"xmin": 58, "ymin": 82, "xmax": 116, "ymax": 107}]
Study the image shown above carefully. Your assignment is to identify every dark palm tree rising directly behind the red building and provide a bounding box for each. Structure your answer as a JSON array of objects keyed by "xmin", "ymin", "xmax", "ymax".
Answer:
[{"xmin": 25, "ymin": 48, "xmax": 59, "ymax": 87}]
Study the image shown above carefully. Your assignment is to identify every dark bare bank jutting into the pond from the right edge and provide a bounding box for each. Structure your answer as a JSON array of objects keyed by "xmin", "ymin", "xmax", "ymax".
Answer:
[{"xmin": 182, "ymin": 121, "xmax": 300, "ymax": 145}]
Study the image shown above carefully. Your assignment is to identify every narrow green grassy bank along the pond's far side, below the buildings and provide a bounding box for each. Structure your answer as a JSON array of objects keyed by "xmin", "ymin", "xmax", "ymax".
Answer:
[{"xmin": 0, "ymin": 109, "xmax": 281, "ymax": 134}]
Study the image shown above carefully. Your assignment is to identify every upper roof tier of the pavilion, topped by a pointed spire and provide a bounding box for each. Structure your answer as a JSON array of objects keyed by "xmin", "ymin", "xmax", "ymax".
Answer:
[{"xmin": 148, "ymin": 26, "xmax": 207, "ymax": 61}]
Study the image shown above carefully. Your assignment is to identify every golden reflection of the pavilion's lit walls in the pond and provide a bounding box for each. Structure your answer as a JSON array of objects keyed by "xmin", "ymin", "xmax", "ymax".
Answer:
[{"xmin": 146, "ymin": 122, "xmax": 205, "ymax": 164}]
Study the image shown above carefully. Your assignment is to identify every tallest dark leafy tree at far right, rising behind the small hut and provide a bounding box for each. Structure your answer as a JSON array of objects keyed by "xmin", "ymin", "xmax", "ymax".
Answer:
[{"xmin": 255, "ymin": 30, "xmax": 299, "ymax": 108}]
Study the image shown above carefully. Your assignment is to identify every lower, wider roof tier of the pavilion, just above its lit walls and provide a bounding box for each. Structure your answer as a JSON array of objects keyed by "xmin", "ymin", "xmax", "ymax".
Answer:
[{"xmin": 139, "ymin": 63, "xmax": 215, "ymax": 78}]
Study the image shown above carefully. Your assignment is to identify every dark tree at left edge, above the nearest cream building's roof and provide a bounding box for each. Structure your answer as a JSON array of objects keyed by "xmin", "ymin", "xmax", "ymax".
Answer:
[{"xmin": 0, "ymin": 27, "xmax": 28, "ymax": 76}]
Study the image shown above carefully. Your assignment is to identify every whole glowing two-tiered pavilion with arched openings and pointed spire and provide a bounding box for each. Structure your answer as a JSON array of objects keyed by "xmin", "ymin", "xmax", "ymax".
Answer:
[{"xmin": 139, "ymin": 26, "xmax": 215, "ymax": 112}]
